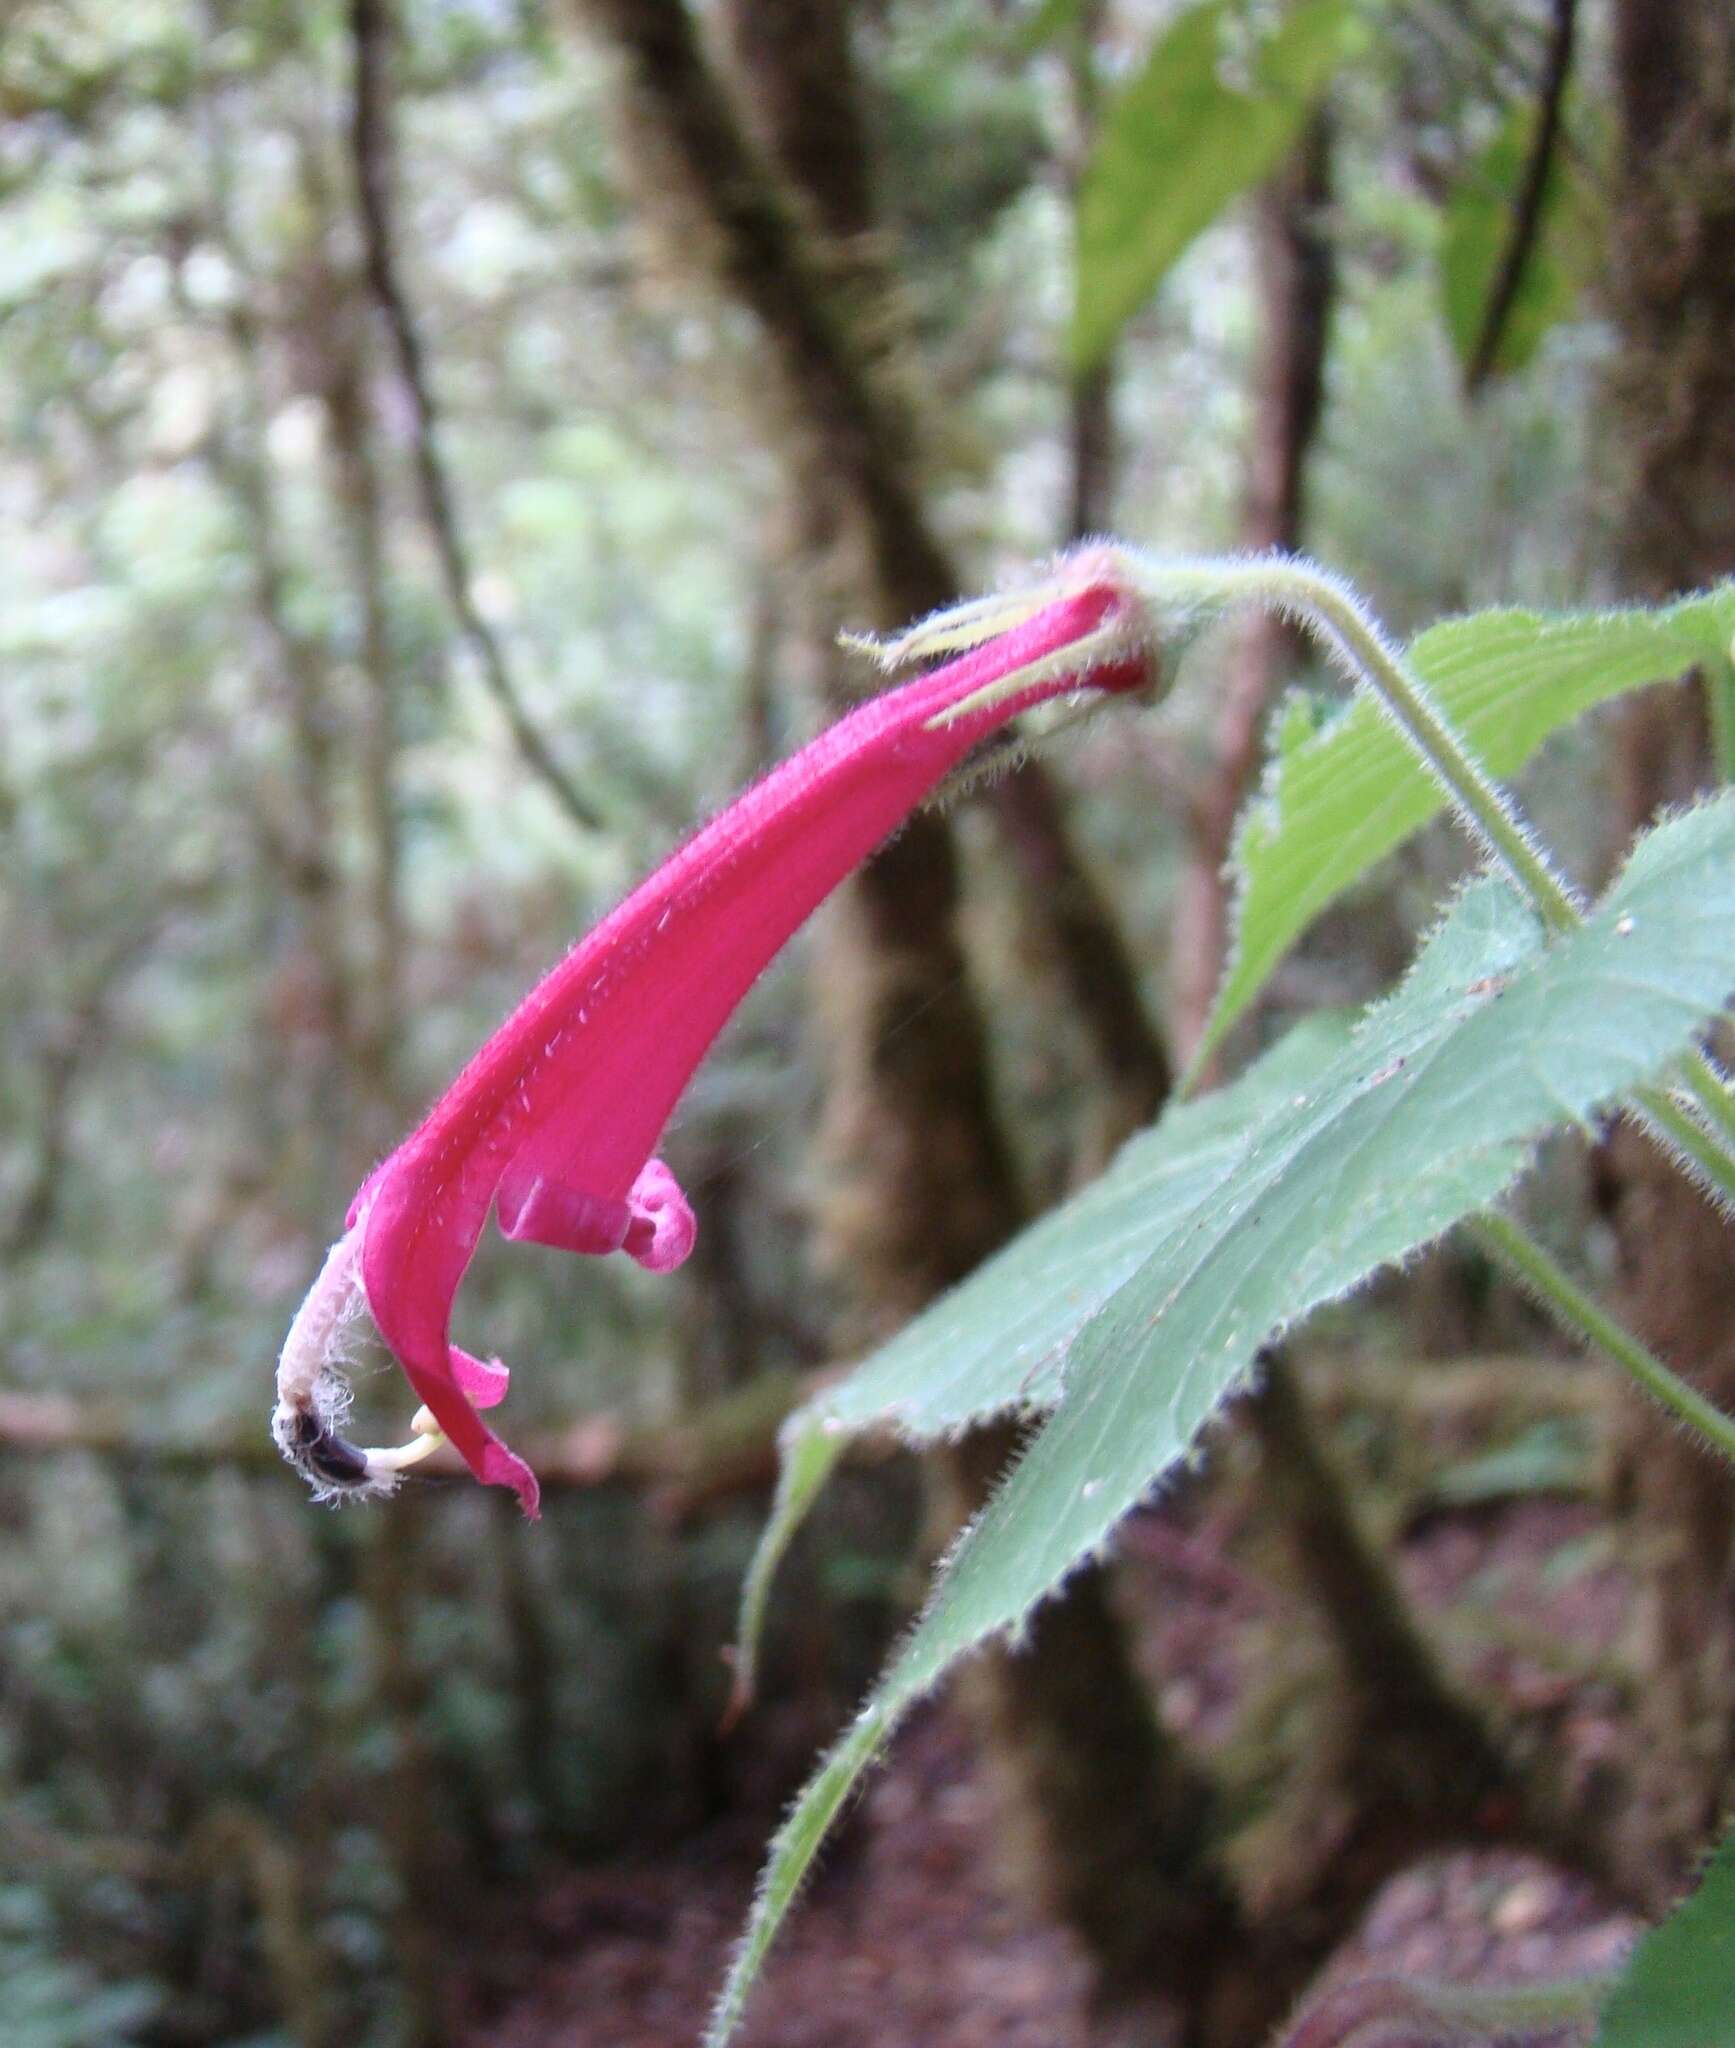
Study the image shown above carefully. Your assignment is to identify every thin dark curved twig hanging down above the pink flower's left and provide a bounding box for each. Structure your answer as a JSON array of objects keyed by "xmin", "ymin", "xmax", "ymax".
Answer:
[{"xmin": 350, "ymin": 0, "xmax": 602, "ymax": 831}]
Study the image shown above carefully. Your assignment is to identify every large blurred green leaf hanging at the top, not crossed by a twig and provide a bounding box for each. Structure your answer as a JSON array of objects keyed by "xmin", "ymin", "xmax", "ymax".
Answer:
[{"xmin": 1071, "ymin": 0, "xmax": 1360, "ymax": 371}]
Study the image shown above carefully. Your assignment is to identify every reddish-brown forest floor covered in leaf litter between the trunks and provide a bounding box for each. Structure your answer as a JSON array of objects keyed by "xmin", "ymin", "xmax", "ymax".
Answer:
[{"xmin": 448, "ymin": 1376, "xmax": 1635, "ymax": 2048}]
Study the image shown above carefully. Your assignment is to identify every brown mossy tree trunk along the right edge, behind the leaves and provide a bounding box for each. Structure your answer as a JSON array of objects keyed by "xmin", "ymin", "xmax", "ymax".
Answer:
[{"xmin": 1598, "ymin": 0, "xmax": 1735, "ymax": 1896}]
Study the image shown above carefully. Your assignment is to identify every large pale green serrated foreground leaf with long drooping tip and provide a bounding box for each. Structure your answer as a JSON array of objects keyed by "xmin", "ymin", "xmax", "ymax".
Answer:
[{"xmin": 711, "ymin": 795, "xmax": 1735, "ymax": 2048}]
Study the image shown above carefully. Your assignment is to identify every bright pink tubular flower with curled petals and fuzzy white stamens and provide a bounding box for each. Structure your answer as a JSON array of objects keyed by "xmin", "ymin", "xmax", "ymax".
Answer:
[{"xmin": 272, "ymin": 547, "xmax": 1151, "ymax": 1516}]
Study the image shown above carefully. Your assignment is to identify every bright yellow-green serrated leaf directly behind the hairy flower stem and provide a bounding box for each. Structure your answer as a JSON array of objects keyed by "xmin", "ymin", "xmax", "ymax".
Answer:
[{"xmin": 1194, "ymin": 584, "xmax": 1735, "ymax": 1067}]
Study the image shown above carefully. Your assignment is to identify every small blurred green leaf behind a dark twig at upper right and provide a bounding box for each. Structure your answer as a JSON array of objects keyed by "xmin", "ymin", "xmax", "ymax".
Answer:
[{"xmin": 1440, "ymin": 106, "xmax": 1577, "ymax": 373}]
